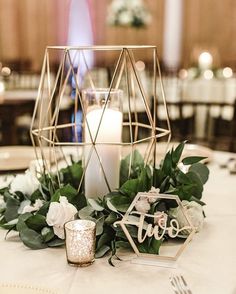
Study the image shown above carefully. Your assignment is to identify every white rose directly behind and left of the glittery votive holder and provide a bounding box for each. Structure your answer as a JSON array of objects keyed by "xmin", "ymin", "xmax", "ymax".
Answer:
[{"xmin": 46, "ymin": 196, "xmax": 77, "ymax": 239}]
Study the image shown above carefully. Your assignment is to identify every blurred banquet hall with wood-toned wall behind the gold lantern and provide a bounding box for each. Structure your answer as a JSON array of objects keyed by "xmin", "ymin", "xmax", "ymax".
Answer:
[{"xmin": 0, "ymin": 0, "xmax": 236, "ymax": 151}]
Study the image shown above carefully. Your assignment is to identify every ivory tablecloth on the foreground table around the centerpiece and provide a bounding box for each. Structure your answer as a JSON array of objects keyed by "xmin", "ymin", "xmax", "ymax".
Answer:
[{"xmin": 0, "ymin": 152, "xmax": 236, "ymax": 294}]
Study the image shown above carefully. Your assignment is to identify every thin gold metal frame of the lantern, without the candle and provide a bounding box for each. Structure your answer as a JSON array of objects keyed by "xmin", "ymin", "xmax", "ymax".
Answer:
[{"xmin": 30, "ymin": 46, "xmax": 171, "ymax": 191}]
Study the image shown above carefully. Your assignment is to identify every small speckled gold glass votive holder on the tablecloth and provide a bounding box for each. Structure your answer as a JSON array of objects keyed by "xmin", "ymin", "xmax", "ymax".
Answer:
[{"xmin": 65, "ymin": 220, "xmax": 96, "ymax": 267}]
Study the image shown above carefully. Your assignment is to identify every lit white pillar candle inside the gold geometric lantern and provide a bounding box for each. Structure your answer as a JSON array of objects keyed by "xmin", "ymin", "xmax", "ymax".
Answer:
[{"xmin": 85, "ymin": 95, "xmax": 122, "ymax": 198}]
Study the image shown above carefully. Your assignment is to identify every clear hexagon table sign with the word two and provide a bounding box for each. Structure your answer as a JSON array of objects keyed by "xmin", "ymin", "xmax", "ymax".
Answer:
[{"xmin": 114, "ymin": 190, "xmax": 195, "ymax": 267}]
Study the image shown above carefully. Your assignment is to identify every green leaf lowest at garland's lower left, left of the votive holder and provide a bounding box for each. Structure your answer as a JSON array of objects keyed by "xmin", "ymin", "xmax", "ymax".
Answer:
[{"xmin": 20, "ymin": 228, "xmax": 47, "ymax": 249}]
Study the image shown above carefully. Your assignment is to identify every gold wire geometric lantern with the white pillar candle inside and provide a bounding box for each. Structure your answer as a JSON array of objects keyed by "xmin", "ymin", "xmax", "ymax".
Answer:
[{"xmin": 31, "ymin": 46, "xmax": 171, "ymax": 198}]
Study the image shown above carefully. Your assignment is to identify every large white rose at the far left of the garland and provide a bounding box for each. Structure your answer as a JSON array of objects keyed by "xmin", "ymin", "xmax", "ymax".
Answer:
[{"xmin": 10, "ymin": 170, "xmax": 40, "ymax": 196}]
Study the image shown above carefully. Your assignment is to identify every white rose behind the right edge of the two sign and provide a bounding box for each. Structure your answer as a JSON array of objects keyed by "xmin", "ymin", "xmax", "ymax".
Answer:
[{"xmin": 171, "ymin": 200, "xmax": 204, "ymax": 233}]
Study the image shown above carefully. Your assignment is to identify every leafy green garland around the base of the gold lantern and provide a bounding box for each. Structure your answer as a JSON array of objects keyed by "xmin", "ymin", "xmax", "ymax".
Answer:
[{"xmin": 0, "ymin": 142, "xmax": 209, "ymax": 263}]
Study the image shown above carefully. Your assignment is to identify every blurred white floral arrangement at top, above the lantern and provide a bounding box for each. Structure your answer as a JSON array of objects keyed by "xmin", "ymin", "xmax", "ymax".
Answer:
[{"xmin": 107, "ymin": 0, "xmax": 151, "ymax": 28}]
